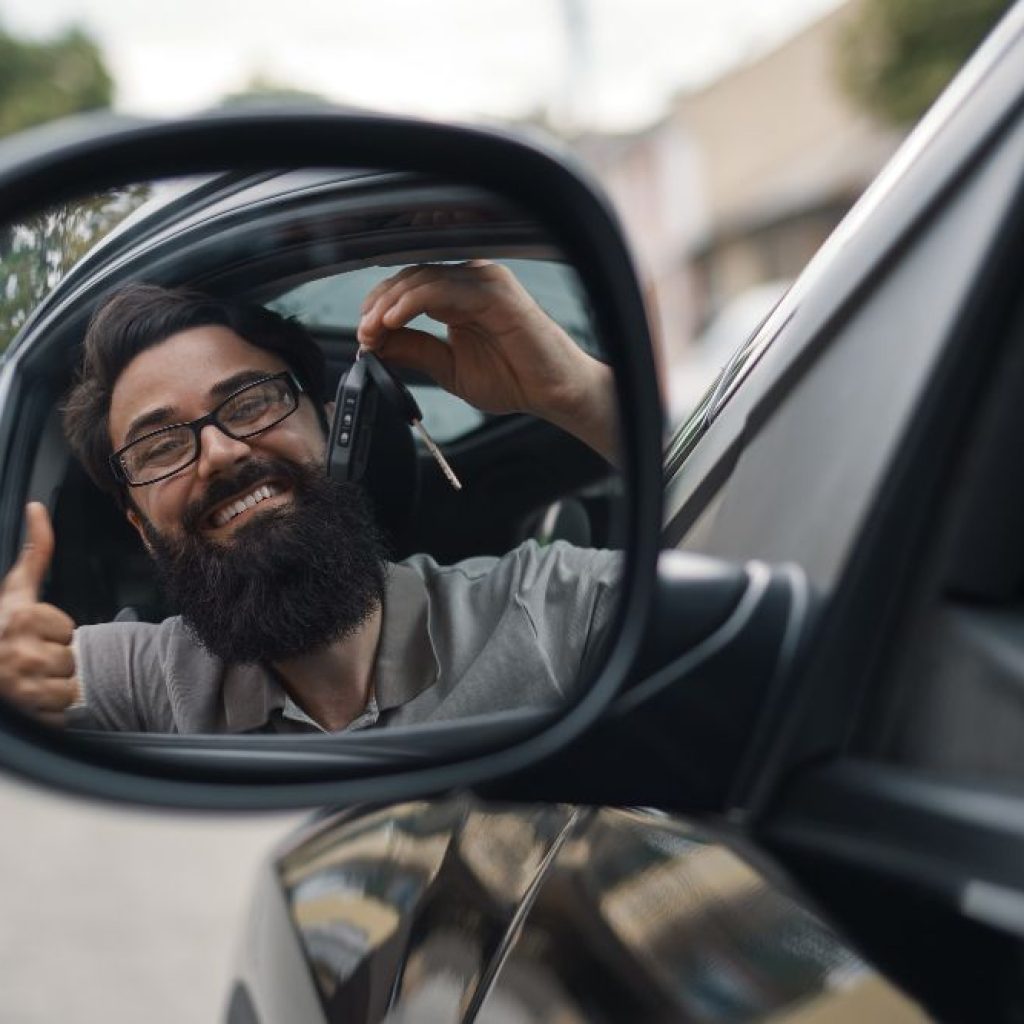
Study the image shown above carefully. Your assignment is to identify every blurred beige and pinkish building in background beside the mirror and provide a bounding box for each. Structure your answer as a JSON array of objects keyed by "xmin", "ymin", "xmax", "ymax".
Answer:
[{"xmin": 573, "ymin": 0, "xmax": 901, "ymax": 415}]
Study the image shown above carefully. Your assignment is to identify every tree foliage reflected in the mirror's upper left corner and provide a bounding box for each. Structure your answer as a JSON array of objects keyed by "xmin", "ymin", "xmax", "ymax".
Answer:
[{"xmin": 0, "ymin": 184, "xmax": 151, "ymax": 349}]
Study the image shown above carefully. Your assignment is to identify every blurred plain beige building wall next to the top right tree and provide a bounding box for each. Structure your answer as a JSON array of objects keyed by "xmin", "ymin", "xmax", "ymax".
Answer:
[{"xmin": 671, "ymin": 0, "xmax": 901, "ymax": 314}]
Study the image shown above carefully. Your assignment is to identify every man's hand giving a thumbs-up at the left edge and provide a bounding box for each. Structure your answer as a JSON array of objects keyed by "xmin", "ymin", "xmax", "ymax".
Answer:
[{"xmin": 0, "ymin": 502, "xmax": 80, "ymax": 723}]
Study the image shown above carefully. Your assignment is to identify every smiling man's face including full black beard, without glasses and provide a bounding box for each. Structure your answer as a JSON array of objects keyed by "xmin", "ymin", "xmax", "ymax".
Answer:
[{"xmin": 110, "ymin": 327, "xmax": 386, "ymax": 663}]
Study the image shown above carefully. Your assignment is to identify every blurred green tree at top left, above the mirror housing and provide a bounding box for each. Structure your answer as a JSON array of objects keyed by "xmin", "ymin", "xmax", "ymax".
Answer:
[{"xmin": 0, "ymin": 29, "xmax": 113, "ymax": 135}]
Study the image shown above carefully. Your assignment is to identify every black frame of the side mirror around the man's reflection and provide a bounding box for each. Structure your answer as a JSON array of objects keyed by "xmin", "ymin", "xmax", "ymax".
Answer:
[{"xmin": 0, "ymin": 103, "xmax": 662, "ymax": 808}]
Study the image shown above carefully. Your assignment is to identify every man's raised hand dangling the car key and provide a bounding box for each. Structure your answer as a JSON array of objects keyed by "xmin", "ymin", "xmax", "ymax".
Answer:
[{"xmin": 357, "ymin": 260, "xmax": 616, "ymax": 461}]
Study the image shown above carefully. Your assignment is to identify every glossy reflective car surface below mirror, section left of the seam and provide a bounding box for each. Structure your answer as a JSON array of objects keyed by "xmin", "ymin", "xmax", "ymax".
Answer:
[{"xmin": 280, "ymin": 802, "xmax": 569, "ymax": 1021}]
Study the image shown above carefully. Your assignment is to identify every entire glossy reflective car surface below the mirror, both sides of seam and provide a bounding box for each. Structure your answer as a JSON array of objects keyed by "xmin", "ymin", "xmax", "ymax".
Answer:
[{"xmin": 268, "ymin": 798, "xmax": 916, "ymax": 1024}]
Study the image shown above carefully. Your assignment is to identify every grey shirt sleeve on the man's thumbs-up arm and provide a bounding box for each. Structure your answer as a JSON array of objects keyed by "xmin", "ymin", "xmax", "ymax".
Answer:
[{"xmin": 68, "ymin": 623, "xmax": 177, "ymax": 732}]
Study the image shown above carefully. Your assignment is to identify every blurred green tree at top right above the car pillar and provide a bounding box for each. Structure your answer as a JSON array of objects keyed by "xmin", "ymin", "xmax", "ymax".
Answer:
[{"xmin": 838, "ymin": 0, "xmax": 1011, "ymax": 127}]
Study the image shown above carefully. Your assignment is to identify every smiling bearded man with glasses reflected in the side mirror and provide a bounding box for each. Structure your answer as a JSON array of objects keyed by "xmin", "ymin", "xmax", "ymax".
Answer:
[{"xmin": 0, "ymin": 263, "xmax": 620, "ymax": 733}]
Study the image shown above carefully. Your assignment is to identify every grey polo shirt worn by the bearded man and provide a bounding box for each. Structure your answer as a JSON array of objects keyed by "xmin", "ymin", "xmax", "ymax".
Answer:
[{"xmin": 70, "ymin": 541, "xmax": 622, "ymax": 733}]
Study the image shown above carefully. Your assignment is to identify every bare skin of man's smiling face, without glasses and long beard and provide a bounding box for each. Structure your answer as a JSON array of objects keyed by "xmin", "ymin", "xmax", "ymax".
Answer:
[{"xmin": 110, "ymin": 326, "xmax": 326, "ymax": 544}]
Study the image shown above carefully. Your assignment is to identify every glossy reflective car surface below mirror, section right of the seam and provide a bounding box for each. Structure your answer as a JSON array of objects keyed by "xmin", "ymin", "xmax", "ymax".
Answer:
[{"xmin": 483, "ymin": 810, "xmax": 864, "ymax": 1021}]
